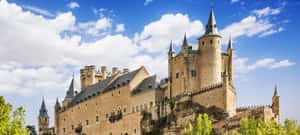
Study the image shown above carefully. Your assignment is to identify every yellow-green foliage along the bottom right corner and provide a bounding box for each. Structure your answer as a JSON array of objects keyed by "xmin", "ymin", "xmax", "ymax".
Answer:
[{"xmin": 233, "ymin": 118, "xmax": 300, "ymax": 135}]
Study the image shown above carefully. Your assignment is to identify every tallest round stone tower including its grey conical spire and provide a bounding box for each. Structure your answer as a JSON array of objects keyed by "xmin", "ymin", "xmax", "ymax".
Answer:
[{"xmin": 198, "ymin": 8, "xmax": 222, "ymax": 87}]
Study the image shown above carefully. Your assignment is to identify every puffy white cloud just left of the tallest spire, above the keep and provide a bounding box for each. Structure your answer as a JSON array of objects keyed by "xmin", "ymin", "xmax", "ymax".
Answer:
[{"xmin": 135, "ymin": 13, "xmax": 204, "ymax": 52}]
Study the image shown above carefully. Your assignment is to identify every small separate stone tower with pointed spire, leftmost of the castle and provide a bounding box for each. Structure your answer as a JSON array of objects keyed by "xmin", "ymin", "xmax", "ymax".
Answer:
[{"xmin": 38, "ymin": 98, "xmax": 49, "ymax": 135}]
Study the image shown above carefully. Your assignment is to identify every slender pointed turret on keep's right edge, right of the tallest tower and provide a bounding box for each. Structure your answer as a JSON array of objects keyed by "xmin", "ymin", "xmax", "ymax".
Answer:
[{"xmin": 227, "ymin": 37, "xmax": 233, "ymax": 86}]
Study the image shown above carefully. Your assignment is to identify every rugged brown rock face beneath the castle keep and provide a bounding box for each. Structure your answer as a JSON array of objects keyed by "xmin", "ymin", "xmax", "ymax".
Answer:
[{"xmin": 141, "ymin": 100, "xmax": 228, "ymax": 135}]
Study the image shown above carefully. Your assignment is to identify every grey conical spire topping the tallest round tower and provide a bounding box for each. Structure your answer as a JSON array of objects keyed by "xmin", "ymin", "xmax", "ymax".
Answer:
[{"xmin": 204, "ymin": 7, "xmax": 219, "ymax": 35}]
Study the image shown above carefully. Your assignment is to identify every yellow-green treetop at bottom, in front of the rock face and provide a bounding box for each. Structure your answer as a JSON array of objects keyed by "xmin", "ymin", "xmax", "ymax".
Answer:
[{"xmin": 184, "ymin": 114, "xmax": 213, "ymax": 135}]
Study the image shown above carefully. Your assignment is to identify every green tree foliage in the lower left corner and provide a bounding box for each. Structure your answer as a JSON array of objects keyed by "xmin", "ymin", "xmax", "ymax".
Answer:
[{"xmin": 0, "ymin": 96, "xmax": 30, "ymax": 135}]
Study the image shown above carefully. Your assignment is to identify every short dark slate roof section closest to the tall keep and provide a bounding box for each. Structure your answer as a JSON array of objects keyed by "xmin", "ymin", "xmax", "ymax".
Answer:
[{"xmin": 131, "ymin": 75, "xmax": 161, "ymax": 95}]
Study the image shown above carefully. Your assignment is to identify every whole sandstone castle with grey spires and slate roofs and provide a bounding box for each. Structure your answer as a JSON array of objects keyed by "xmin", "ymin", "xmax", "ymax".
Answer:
[{"xmin": 38, "ymin": 9, "xmax": 280, "ymax": 135}]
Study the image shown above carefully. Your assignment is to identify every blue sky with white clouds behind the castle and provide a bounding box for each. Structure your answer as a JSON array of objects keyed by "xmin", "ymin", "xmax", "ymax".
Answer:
[{"xmin": 0, "ymin": 0, "xmax": 300, "ymax": 125}]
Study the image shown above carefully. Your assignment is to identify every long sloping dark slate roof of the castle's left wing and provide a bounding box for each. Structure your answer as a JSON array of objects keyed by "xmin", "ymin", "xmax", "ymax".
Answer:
[{"xmin": 71, "ymin": 68, "xmax": 140, "ymax": 106}]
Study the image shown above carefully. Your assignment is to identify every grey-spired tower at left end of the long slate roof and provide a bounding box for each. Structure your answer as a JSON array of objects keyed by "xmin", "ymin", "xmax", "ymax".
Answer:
[{"xmin": 63, "ymin": 76, "xmax": 77, "ymax": 108}]
